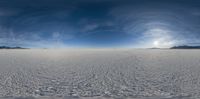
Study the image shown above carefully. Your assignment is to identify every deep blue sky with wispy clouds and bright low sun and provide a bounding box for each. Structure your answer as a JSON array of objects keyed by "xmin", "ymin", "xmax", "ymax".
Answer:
[{"xmin": 0, "ymin": 0, "xmax": 200, "ymax": 48}]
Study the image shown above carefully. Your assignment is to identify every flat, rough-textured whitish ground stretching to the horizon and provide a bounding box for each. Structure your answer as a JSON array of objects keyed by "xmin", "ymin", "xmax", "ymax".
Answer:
[{"xmin": 0, "ymin": 49, "xmax": 200, "ymax": 99}]
